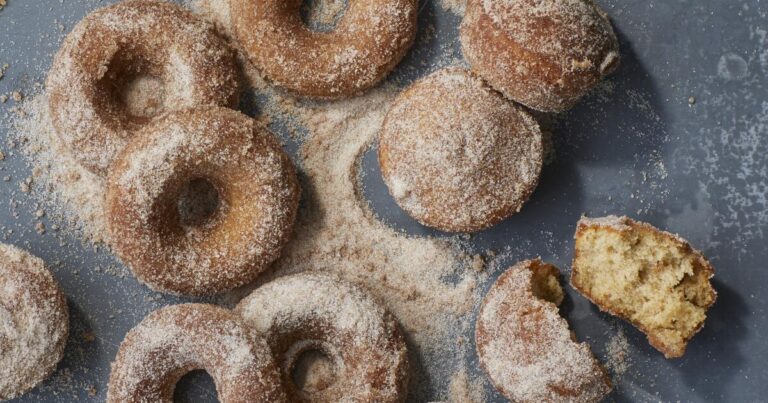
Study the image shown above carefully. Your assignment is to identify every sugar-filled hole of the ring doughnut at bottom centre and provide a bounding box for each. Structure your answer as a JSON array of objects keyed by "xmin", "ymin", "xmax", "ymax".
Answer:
[{"xmin": 291, "ymin": 348, "xmax": 337, "ymax": 396}]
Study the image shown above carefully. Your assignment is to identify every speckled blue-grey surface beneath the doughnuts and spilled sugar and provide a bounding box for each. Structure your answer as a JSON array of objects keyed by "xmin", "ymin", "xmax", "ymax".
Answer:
[{"xmin": 0, "ymin": 0, "xmax": 768, "ymax": 402}]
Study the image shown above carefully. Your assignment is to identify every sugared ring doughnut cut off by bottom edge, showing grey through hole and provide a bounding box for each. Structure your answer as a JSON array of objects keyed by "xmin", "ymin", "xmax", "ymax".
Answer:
[{"xmin": 107, "ymin": 304, "xmax": 286, "ymax": 403}]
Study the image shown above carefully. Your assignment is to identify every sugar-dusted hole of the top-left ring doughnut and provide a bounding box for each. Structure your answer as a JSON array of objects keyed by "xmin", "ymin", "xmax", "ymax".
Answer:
[{"xmin": 97, "ymin": 51, "xmax": 167, "ymax": 128}]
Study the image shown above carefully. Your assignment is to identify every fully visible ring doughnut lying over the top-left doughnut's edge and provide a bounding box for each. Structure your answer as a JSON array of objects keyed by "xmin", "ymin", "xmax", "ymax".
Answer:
[{"xmin": 106, "ymin": 106, "xmax": 300, "ymax": 295}]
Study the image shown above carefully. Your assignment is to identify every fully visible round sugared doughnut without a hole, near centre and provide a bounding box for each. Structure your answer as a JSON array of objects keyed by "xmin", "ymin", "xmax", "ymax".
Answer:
[{"xmin": 379, "ymin": 68, "xmax": 544, "ymax": 232}]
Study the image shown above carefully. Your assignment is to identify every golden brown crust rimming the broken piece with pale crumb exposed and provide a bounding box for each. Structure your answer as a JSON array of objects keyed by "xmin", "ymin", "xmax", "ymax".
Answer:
[{"xmin": 570, "ymin": 216, "xmax": 717, "ymax": 358}]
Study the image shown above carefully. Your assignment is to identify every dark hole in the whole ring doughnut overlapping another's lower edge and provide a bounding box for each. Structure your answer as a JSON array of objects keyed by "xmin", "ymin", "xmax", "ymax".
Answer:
[{"xmin": 177, "ymin": 178, "xmax": 221, "ymax": 227}]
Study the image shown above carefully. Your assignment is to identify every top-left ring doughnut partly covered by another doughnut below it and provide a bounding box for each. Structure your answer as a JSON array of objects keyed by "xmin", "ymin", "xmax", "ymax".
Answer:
[{"xmin": 46, "ymin": 0, "xmax": 239, "ymax": 176}]
